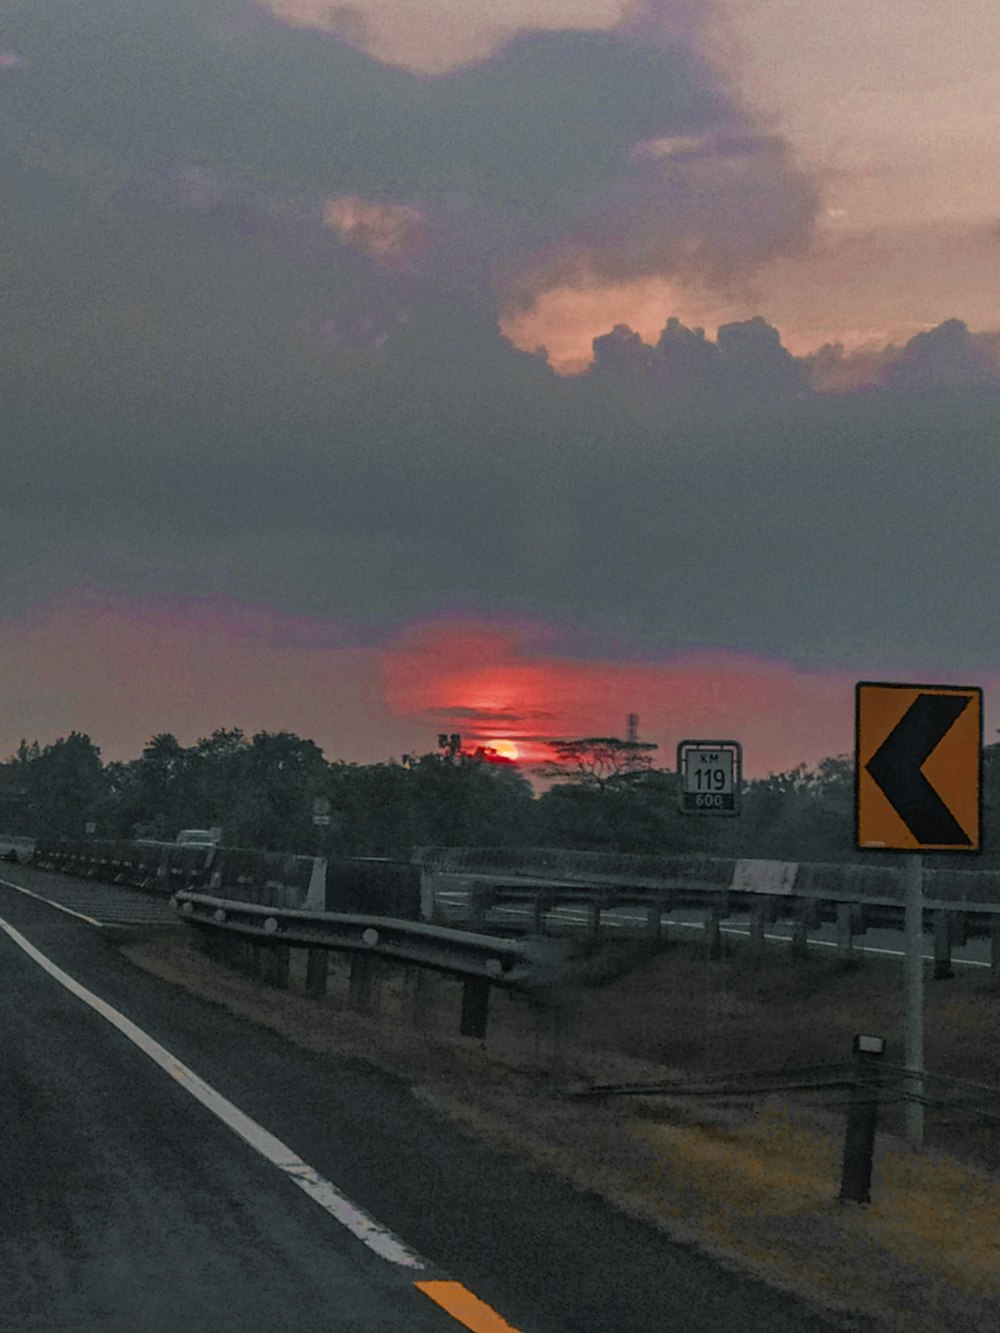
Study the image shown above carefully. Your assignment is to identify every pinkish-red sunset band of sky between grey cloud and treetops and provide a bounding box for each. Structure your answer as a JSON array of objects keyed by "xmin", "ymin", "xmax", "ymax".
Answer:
[{"xmin": 0, "ymin": 596, "xmax": 1000, "ymax": 777}]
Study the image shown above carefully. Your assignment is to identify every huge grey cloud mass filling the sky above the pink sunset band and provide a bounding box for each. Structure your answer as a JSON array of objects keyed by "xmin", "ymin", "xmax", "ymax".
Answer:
[{"xmin": 0, "ymin": 0, "xmax": 1000, "ymax": 687}]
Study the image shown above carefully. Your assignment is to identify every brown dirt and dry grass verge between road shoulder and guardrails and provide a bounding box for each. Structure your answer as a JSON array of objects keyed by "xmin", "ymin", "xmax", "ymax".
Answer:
[{"xmin": 125, "ymin": 936, "xmax": 1000, "ymax": 1333}]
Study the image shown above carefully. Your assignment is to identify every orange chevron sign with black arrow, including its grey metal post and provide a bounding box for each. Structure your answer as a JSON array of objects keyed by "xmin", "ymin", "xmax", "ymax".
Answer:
[{"xmin": 855, "ymin": 681, "xmax": 983, "ymax": 1146}]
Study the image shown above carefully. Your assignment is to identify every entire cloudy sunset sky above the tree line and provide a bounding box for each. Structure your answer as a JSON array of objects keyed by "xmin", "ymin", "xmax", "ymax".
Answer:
[{"xmin": 0, "ymin": 0, "xmax": 1000, "ymax": 776}]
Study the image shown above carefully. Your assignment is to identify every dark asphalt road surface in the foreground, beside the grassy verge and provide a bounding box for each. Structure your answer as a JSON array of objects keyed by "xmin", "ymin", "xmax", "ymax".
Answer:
[{"xmin": 0, "ymin": 868, "xmax": 848, "ymax": 1333}]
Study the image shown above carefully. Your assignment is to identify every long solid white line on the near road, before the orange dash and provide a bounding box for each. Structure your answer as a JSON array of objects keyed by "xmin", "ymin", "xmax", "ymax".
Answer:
[{"xmin": 0, "ymin": 917, "xmax": 429, "ymax": 1269}]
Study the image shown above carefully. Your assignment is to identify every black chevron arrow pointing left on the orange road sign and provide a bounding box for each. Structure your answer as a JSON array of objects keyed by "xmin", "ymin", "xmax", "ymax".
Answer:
[{"xmin": 865, "ymin": 694, "xmax": 972, "ymax": 846}]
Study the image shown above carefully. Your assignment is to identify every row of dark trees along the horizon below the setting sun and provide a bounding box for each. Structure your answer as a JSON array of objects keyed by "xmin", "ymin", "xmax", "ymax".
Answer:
[{"xmin": 0, "ymin": 729, "xmax": 1000, "ymax": 869}]
